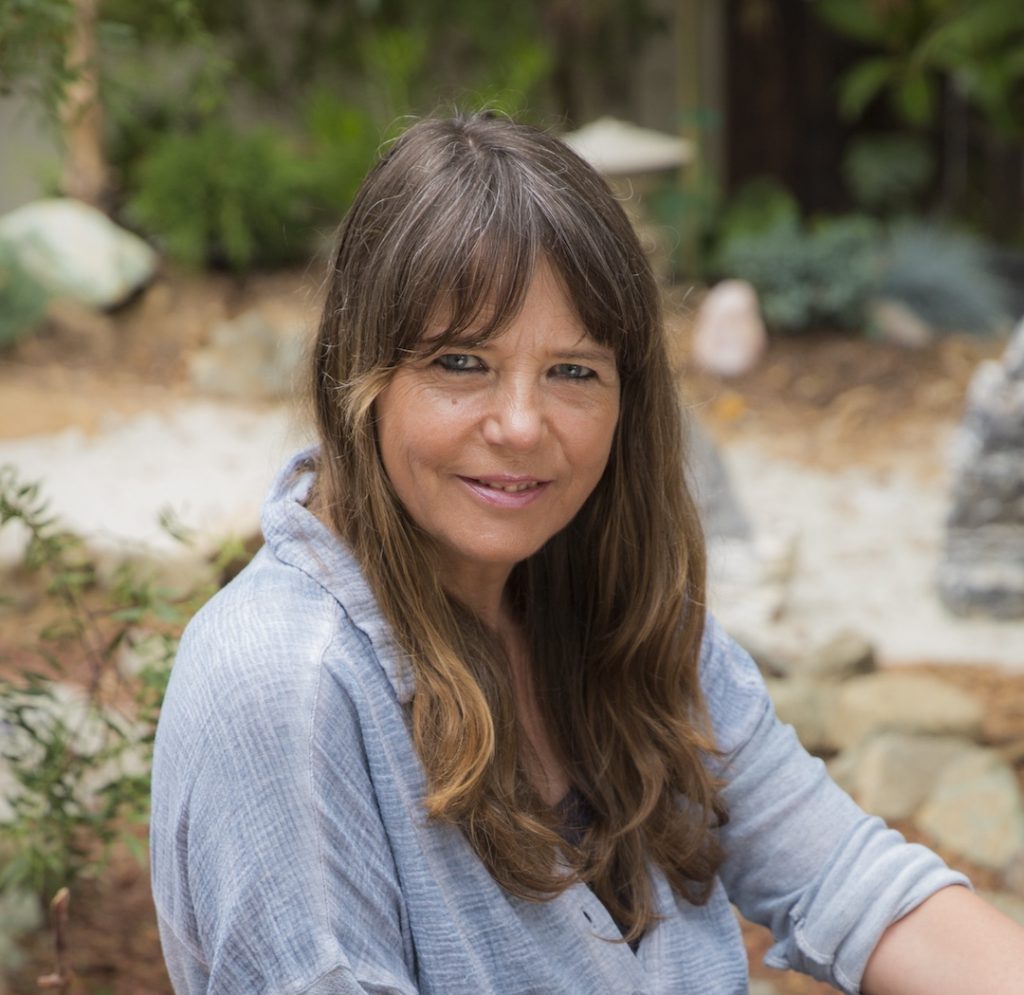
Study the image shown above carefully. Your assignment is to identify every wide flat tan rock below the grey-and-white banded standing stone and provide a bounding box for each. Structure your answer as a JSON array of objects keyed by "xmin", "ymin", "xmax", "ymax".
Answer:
[{"xmin": 830, "ymin": 672, "xmax": 982, "ymax": 748}]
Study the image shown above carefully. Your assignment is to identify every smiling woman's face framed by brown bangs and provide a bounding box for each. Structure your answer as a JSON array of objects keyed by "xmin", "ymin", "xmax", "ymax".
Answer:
[{"xmin": 376, "ymin": 263, "xmax": 618, "ymax": 602}]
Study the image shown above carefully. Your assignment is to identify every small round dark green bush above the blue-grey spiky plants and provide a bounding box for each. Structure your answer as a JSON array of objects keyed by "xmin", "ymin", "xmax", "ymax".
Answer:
[{"xmin": 843, "ymin": 134, "xmax": 935, "ymax": 215}]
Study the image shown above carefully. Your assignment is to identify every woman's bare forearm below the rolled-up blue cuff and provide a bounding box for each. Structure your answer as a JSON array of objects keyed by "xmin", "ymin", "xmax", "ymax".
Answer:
[{"xmin": 861, "ymin": 888, "xmax": 1024, "ymax": 995}]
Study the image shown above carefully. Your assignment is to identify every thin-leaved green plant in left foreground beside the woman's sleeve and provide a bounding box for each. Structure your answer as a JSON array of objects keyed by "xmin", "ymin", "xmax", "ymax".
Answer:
[{"xmin": 0, "ymin": 467, "xmax": 238, "ymax": 899}]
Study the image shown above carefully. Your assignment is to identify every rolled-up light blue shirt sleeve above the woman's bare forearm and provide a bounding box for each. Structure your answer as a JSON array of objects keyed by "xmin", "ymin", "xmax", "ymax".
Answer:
[{"xmin": 701, "ymin": 618, "xmax": 970, "ymax": 995}]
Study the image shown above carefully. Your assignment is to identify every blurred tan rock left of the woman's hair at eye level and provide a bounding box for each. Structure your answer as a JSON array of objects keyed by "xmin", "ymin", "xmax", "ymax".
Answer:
[{"xmin": 188, "ymin": 309, "xmax": 308, "ymax": 400}]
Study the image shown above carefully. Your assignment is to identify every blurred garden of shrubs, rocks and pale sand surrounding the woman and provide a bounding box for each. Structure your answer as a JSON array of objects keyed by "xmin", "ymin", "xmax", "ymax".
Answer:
[{"xmin": 0, "ymin": 0, "xmax": 1024, "ymax": 995}]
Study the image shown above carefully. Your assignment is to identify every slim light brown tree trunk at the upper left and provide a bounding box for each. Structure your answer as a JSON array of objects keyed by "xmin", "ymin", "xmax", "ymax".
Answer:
[{"xmin": 60, "ymin": 0, "xmax": 108, "ymax": 207}]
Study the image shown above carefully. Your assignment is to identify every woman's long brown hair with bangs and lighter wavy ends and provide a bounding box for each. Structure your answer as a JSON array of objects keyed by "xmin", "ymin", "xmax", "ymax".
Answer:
[{"xmin": 313, "ymin": 115, "xmax": 724, "ymax": 939}]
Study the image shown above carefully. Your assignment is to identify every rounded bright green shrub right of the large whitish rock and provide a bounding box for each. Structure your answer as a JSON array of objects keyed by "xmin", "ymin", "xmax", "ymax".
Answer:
[{"xmin": 126, "ymin": 120, "xmax": 315, "ymax": 270}]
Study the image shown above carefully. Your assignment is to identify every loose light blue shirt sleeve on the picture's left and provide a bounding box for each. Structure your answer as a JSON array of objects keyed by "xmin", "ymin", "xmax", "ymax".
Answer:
[{"xmin": 151, "ymin": 597, "xmax": 417, "ymax": 995}]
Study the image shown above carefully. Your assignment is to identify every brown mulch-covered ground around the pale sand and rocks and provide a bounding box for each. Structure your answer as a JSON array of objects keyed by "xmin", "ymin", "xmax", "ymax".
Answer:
[{"xmin": 0, "ymin": 273, "xmax": 1024, "ymax": 995}]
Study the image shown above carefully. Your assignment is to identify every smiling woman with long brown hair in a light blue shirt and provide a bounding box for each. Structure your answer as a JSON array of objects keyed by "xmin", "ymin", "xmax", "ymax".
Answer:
[{"xmin": 152, "ymin": 117, "xmax": 1024, "ymax": 995}]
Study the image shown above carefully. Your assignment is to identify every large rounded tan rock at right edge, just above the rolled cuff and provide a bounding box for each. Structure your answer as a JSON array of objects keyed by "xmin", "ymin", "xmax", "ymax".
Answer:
[{"xmin": 916, "ymin": 746, "xmax": 1024, "ymax": 870}]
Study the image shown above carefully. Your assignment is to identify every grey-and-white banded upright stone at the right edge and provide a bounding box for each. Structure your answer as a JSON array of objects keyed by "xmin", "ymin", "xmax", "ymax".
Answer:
[{"xmin": 938, "ymin": 321, "xmax": 1024, "ymax": 618}]
